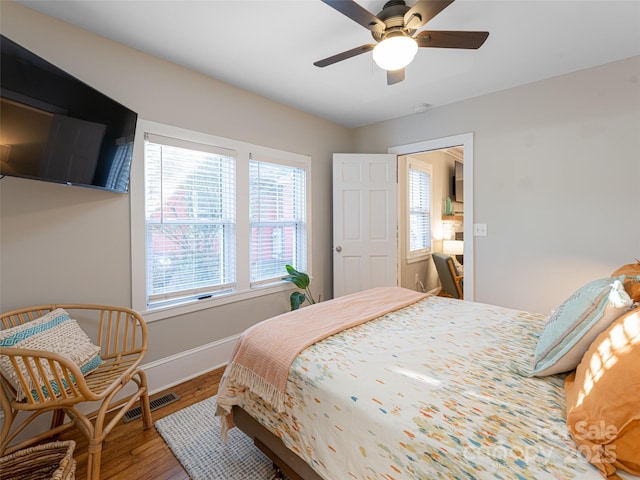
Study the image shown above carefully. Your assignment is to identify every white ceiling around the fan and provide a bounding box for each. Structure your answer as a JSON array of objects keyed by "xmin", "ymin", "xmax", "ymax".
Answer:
[{"xmin": 17, "ymin": 0, "xmax": 640, "ymax": 127}]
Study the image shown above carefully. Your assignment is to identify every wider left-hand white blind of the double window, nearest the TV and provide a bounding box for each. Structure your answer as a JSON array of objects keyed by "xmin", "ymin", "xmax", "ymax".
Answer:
[{"xmin": 144, "ymin": 134, "xmax": 236, "ymax": 305}]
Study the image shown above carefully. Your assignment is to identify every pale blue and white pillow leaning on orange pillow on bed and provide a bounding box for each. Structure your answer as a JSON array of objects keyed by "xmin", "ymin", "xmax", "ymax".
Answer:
[{"xmin": 531, "ymin": 275, "xmax": 633, "ymax": 376}]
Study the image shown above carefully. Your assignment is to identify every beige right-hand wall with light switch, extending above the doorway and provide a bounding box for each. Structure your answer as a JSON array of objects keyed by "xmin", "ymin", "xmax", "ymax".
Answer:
[{"xmin": 355, "ymin": 57, "xmax": 640, "ymax": 313}]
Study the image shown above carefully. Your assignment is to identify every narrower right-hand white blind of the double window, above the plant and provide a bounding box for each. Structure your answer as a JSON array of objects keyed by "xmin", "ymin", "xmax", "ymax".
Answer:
[{"xmin": 249, "ymin": 160, "xmax": 307, "ymax": 285}]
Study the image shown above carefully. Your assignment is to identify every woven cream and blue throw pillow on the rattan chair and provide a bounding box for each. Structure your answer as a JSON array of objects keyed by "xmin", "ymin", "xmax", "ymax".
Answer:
[{"xmin": 0, "ymin": 308, "xmax": 102, "ymax": 400}]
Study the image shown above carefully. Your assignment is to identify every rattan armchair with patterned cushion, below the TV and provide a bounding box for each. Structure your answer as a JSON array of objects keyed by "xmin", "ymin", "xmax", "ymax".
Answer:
[{"xmin": 0, "ymin": 304, "xmax": 153, "ymax": 480}]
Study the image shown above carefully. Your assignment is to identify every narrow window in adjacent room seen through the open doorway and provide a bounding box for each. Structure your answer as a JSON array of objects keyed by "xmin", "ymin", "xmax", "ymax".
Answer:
[{"xmin": 408, "ymin": 161, "xmax": 431, "ymax": 257}]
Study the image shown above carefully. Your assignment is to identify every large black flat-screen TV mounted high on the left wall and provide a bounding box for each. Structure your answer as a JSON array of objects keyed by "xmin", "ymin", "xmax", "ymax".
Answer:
[{"xmin": 0, "ymin": 35, "xmax": 138, "ymax": 193}]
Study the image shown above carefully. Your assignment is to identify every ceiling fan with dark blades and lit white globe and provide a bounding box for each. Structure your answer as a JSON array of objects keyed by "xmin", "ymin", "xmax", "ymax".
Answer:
[{"xmin": 313, "ymin": 0, "xmax": 489, "ymax": 85}]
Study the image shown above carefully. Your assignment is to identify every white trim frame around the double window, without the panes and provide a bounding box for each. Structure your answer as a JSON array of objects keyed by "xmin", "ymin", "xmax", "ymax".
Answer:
[{"xmin": 129, "ymin": 118, "xmax": 313, "ymax": 322}]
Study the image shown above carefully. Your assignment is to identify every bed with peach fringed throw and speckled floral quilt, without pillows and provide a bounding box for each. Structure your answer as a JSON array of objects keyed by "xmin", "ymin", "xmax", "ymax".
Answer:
[{"xmin": 217, "ymin": 287, "xmax": 640, "ymax": 480}]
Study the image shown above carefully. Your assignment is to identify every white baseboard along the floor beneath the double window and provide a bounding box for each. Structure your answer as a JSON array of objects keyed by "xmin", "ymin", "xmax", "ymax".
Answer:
[{"xmin": 0, "ymin": 335, "xmax": 240, "ymax": 444}]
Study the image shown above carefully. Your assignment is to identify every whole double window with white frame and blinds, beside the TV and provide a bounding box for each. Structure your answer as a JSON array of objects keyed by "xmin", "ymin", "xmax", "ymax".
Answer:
[{"xmin": 130, "ymin": 120, "xmax": 311, "ymax": 320}]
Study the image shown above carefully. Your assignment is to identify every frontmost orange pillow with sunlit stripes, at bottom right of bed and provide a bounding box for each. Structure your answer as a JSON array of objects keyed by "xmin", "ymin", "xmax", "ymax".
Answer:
[{"xmin": 565, "ymin": 307, "xmax": 640, "ymax": 478}]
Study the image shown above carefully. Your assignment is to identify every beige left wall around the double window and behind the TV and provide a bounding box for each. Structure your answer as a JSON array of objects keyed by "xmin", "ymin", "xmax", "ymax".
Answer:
[{"xmin": 0, "ymin": 1, "xmax": 352, "ymax": 361}]
